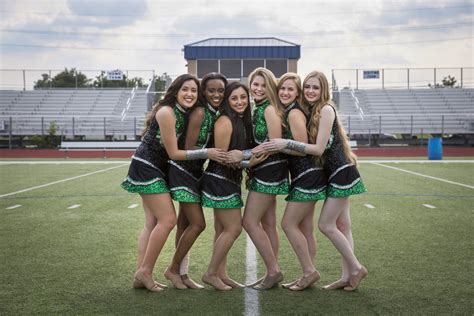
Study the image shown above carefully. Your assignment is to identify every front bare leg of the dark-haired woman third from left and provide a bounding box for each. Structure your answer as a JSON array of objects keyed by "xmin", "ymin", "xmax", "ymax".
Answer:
[{"xmin": 203, "ymin": 209, "xmax": 242, "ymax": 290}]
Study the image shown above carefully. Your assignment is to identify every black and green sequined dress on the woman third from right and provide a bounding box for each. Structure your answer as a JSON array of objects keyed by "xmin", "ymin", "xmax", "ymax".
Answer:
[{"xmin": 249, "ymin": 100, "xmax": 289, "ymax": 195}]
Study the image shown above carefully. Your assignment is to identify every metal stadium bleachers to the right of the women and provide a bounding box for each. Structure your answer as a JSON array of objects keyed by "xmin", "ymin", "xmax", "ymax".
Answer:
[{"xmin": 339, "ymin": 88, "xmax": 474, "ymax": 134}]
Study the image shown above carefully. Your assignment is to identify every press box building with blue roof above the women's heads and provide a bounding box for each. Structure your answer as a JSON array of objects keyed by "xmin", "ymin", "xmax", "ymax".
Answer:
[{"xmin": 184, "ymin": 37, "xmax": 301, "ymax": 80}]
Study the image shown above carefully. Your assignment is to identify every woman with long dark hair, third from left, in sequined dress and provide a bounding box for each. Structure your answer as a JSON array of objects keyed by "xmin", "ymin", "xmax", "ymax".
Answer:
[{"xmin": 202, "ymin": 82, "xmax": 265, "ymax": 291}]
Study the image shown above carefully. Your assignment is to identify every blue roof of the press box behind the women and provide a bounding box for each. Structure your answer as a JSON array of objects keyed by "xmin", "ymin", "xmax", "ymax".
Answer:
[{"xmin": 184, "ymin": 37, "xmax": 301, "ymax": 60}]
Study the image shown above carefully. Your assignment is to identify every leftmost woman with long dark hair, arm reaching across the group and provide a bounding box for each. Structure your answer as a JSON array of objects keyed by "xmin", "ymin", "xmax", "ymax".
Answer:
[{"xmin": 121, "ymin": 75, "xmax": 226, "ymax": 292}]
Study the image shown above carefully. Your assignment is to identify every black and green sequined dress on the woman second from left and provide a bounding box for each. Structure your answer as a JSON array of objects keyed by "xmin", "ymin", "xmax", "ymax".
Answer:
[{"xmin": 168, "ymin": 104, "xmax": 217, "ymax": 203}]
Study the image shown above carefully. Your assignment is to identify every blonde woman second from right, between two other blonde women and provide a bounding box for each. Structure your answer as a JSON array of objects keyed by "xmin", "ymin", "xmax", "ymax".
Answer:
[{"xmin": 277, "ymin": 73, "xmax": 327, "ymax": 291}]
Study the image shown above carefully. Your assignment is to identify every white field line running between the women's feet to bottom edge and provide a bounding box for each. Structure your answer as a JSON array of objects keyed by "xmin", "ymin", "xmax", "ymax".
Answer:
[{"xmin": 244, "ymin": 233, "xmax": 260, "ymax": 316}]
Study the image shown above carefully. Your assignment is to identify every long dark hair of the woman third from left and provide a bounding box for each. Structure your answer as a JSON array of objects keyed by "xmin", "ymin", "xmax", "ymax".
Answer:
[{"xmin": 219, "ymin": 82, "xmax": 252, "ymax": 149}]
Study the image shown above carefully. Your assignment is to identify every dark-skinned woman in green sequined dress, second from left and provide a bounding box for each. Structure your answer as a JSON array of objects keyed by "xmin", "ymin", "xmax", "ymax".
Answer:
[{"xmin": 168, "ymin": 73, "xmax": 227, "ymax": 289}]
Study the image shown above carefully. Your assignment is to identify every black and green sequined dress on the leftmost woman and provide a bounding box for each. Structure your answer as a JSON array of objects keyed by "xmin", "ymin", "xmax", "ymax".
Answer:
[{"xmin": 121, "ymin": 106, "xmax": 184, "ymax": 194}]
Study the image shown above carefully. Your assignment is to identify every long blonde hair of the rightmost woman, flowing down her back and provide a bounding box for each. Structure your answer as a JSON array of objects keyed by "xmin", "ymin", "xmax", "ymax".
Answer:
[{"xmin": 302, "ymin": 71, "xmax": 357, "ymax": 165}]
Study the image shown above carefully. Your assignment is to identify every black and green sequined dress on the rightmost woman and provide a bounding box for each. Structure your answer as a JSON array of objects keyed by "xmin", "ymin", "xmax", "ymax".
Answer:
[{"xmin": 322, "ymin": 104, "xmax": 367, "ymax": 198}]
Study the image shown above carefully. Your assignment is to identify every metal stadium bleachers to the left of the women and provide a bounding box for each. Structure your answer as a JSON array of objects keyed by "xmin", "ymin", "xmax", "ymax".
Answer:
[{"xmin": 0, "ymin": 89, "xmax": 147, "ymax": 139}]
